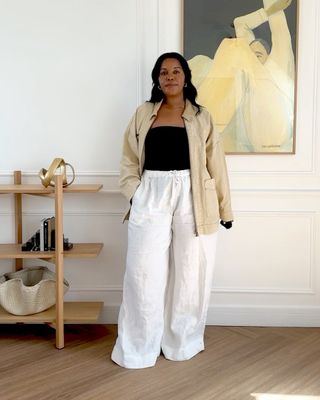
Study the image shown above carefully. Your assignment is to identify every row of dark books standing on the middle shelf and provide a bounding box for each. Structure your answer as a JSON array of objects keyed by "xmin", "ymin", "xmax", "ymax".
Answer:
[{"xmin": 21, "ymin": 217, "xmax": 73, "ymax": 251}]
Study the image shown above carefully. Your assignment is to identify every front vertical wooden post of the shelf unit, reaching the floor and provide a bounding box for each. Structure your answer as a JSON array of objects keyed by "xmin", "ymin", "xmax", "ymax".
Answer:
[{"xmin": 55, "ymin": 175, "xmax": 64, "ymax": 349}]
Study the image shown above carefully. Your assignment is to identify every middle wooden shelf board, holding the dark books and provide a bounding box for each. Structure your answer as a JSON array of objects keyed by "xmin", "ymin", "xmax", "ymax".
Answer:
[{"xmin": 0, "ymin": 243, "xmax": 103, "ymax": 260}]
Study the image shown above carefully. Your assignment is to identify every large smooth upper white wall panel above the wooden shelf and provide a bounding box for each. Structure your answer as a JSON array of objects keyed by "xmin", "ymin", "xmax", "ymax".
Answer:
[{"xmin": 0, "ymin": 0, "xmax": 140, "ymax": 171}]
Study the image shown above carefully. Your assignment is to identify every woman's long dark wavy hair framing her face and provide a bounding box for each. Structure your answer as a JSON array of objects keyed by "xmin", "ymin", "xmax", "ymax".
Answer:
[{"xmin": 149, "ymin": 52, "xmax": 200, "ymax": 112}]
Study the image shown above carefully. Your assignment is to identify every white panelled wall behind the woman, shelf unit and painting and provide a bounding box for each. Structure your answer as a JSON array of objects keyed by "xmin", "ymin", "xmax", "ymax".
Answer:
[{"xmin": 0, "ymin": 0, "xmax": 320, "ymax": 326}]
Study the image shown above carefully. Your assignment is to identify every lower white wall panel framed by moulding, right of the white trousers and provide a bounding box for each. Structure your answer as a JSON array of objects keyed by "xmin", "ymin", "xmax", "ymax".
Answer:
[{"xmin": 214, "ymin": 211, "xmax": 316, "ymax": 294}]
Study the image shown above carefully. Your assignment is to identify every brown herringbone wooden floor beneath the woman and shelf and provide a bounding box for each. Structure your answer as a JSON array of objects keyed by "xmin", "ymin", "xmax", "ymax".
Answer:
[{"xmin": 0, "ymin": 325, "xmax": 320, "ymax": 400}]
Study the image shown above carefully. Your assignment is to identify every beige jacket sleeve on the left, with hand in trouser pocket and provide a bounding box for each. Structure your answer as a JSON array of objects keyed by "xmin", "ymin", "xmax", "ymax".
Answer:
[{"xmin": 119, "ymin": 113, "xmax": 141, "ymax": 201}]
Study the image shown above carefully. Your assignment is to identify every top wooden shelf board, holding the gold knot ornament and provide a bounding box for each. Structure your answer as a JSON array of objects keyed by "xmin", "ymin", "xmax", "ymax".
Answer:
[{"xmin": 0, "ymin": 184, "xmax": 103, "ymax": 195}]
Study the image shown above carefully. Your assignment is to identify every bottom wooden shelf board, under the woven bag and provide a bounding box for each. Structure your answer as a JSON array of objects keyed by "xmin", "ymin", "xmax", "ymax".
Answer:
[{"xmin": 0, "ymin": 302, "xmax": 103, "ymax": 324}]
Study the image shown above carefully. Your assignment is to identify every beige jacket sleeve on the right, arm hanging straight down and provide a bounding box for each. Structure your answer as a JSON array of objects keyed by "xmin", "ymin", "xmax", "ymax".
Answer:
[{"xmin": 206, "ymin": 117, "xmax": 233, "ymax": 221}]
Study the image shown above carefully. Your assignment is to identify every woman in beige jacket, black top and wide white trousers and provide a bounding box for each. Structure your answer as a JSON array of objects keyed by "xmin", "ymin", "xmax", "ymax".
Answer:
[{"xmin": 111, "ymin": 53, "xmax": 233, "ymax": 368}]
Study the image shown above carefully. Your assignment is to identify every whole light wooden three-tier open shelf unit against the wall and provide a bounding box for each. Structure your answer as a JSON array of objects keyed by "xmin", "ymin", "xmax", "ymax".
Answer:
[{"xmin": 0, "ymin": 171, "xmax": 103, "ymax": 349}]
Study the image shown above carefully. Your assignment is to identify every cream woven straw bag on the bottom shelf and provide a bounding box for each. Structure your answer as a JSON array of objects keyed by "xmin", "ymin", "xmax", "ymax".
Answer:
[{"xmin": 0, "ymin": 267, "xmax": 69, "ymax": 315}]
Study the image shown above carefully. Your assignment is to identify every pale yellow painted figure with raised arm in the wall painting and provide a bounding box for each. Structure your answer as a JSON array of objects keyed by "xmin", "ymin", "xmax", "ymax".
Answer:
[{"xmin": 189, "ymin": 0, "xmax": 295, "ymax": 153}]
